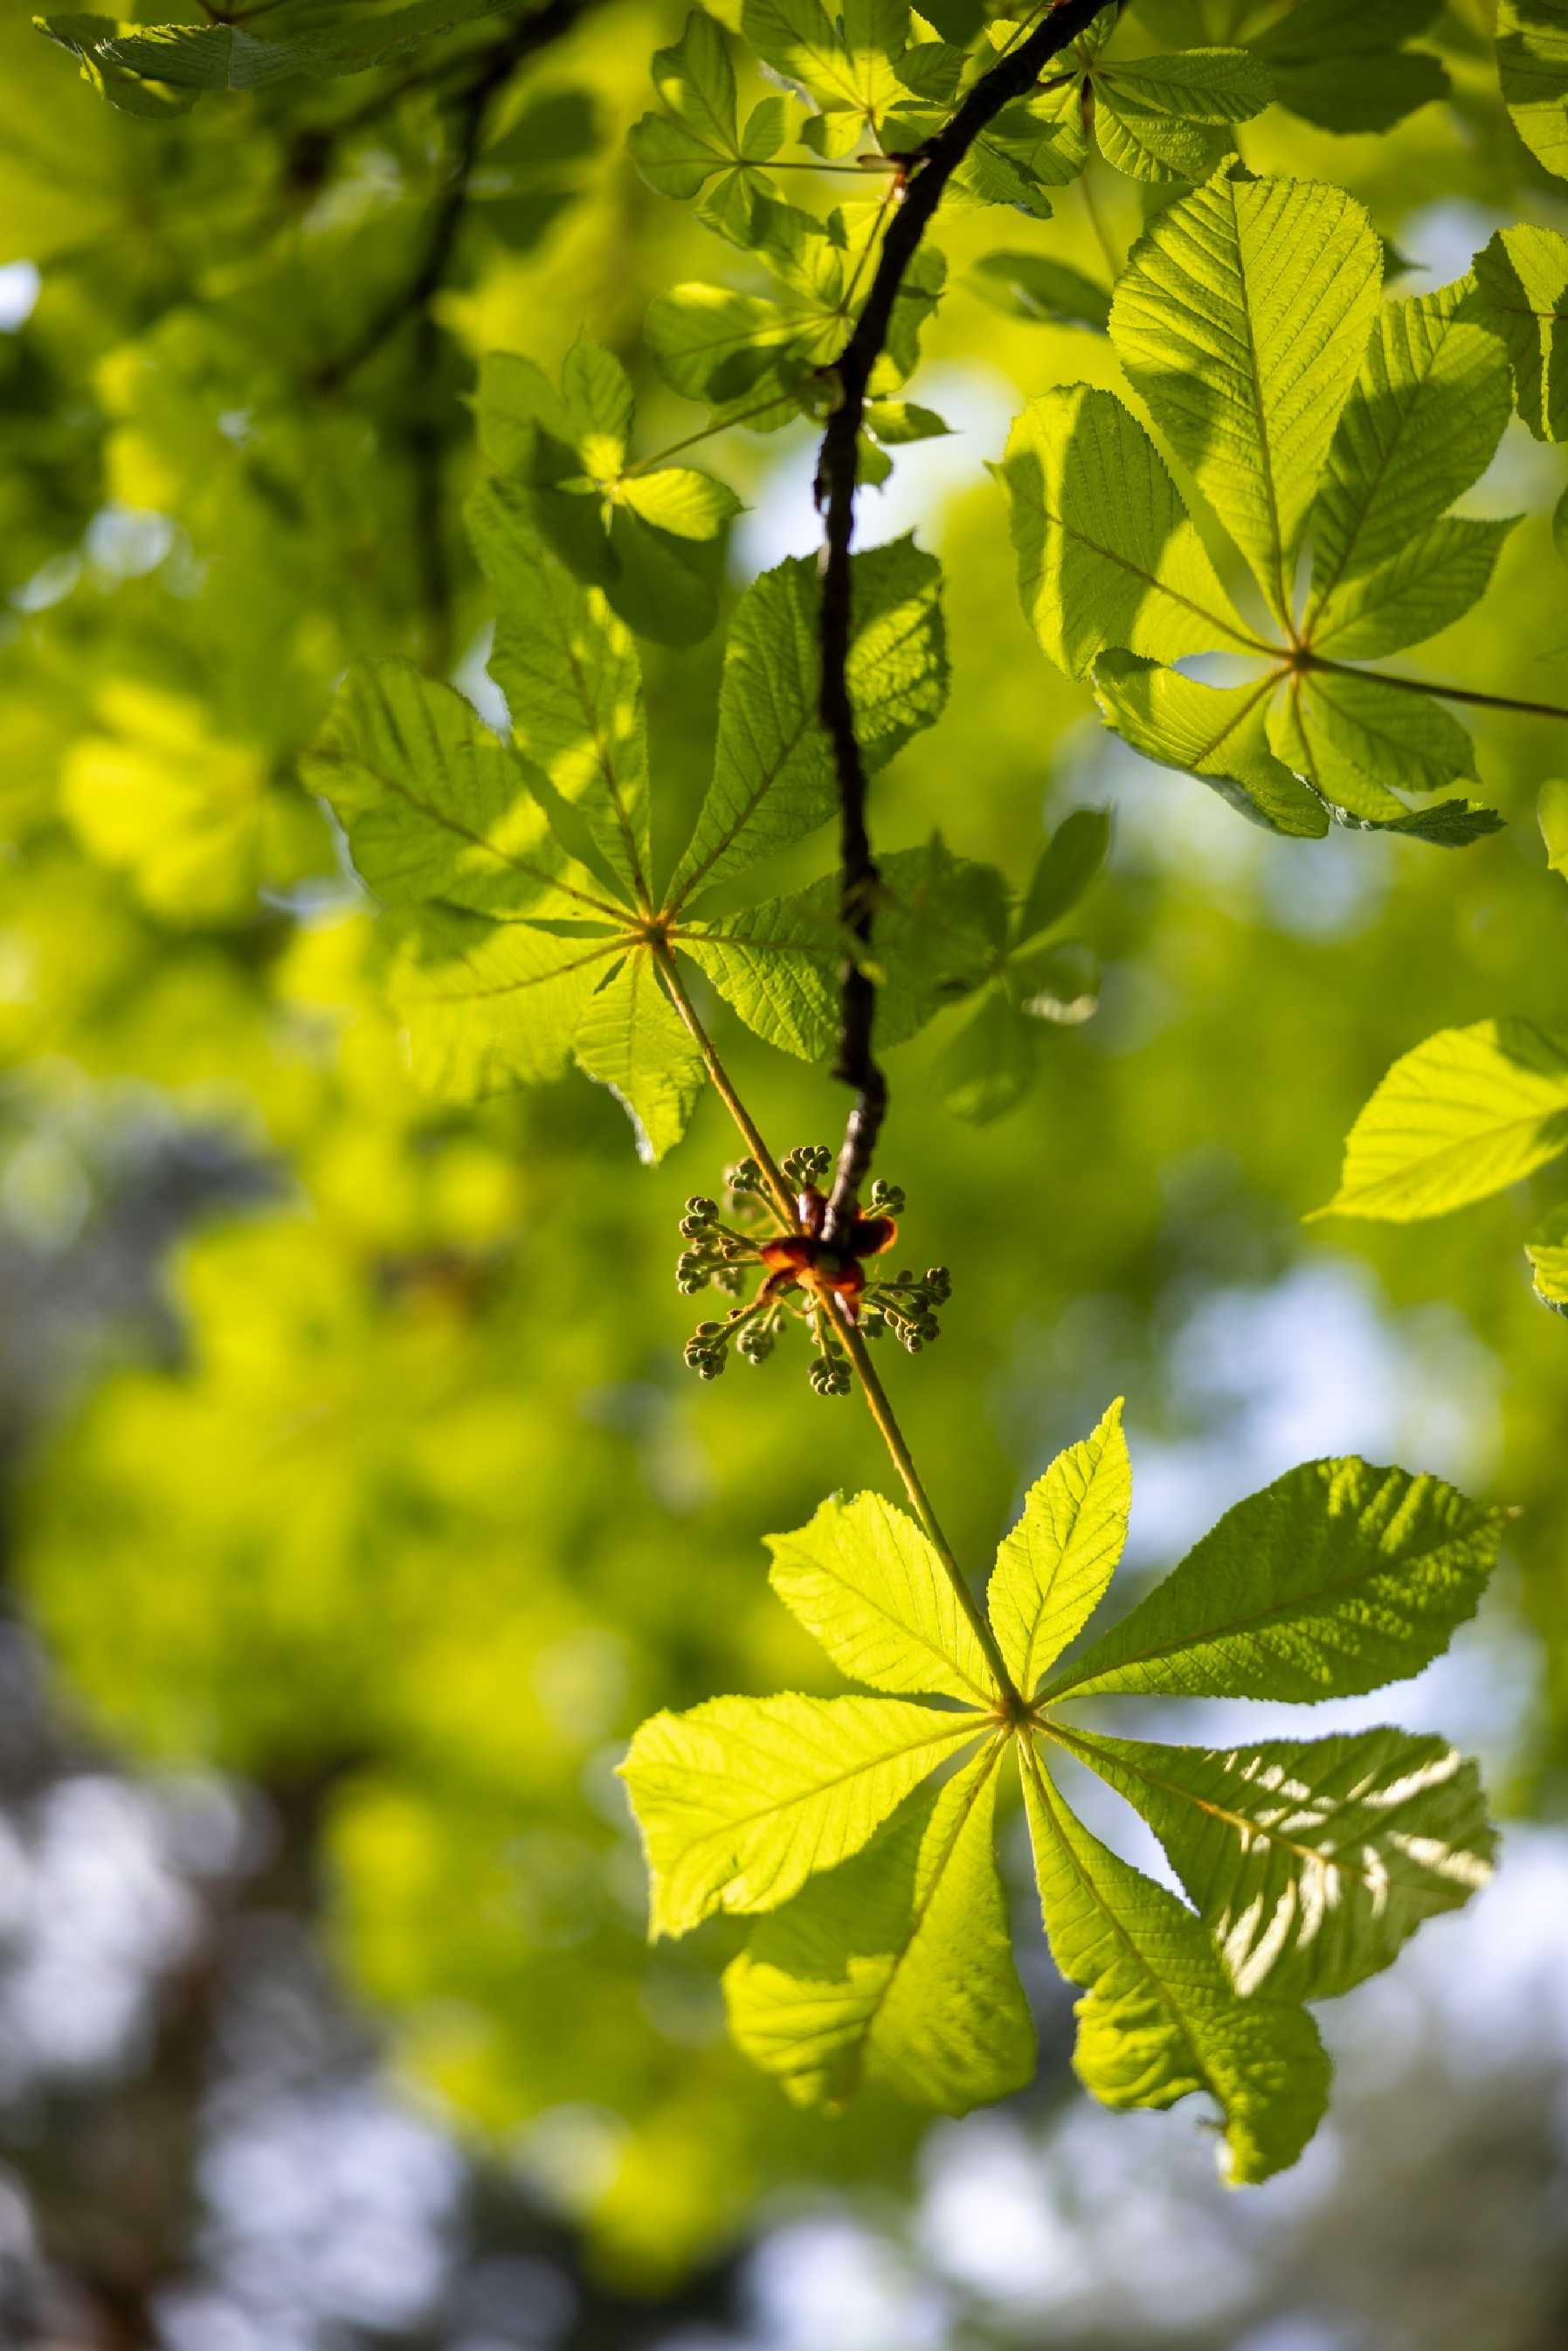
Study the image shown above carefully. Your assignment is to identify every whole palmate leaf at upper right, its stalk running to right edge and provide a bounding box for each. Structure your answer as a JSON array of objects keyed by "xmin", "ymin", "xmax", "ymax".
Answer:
[{"xmin": 1004, "ymin": 206, "xmax": 1504, "ymax": 848}]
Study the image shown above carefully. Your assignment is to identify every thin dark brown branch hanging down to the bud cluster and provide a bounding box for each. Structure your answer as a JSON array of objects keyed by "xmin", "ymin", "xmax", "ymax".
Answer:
[{"xmin": 816, "ymin": 0, "xmax": 1112, "ymax": 1241}]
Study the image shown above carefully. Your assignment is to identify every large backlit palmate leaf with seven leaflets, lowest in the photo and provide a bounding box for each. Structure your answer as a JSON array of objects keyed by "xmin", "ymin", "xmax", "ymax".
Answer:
[{"xmin": 623, "ymin": 1406, "xmax": 1500, "ymax": 2182}]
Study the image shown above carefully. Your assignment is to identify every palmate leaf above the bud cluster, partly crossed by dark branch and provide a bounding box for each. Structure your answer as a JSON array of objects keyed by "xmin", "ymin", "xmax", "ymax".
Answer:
[{"xmin": 306, "ymin": 519, "xmax": 968, "ymax": 1159}]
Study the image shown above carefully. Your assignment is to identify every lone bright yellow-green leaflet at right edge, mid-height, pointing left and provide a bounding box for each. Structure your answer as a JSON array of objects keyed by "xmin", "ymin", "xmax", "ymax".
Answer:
[{"xmin": 1316, "ymin": 1020, "xmax": 1568, "ymax": 1225}]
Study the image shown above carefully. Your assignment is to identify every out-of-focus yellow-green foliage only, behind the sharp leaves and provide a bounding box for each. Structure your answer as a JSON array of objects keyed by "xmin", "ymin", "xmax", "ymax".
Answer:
[{"xmin": 0, "ymin": 0, "xmax": 1568, "ymax": 2283}]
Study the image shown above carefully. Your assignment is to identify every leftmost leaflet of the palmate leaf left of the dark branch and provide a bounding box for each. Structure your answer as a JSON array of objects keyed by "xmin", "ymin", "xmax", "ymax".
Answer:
[{"xmin": 300, "ymin": 660, "xmax": 611, "ymax": 916}]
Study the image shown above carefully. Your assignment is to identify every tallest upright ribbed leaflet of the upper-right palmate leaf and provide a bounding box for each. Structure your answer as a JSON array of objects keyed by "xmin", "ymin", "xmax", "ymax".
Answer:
[{"xmin": 1109, "ymin": 162, "xmax": 1382, "ymax": 620}]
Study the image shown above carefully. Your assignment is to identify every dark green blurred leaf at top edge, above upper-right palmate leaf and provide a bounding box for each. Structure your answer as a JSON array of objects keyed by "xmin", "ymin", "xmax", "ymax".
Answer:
[{"xmin": 1251, "ymin": 0, "xmax": 1448, "ymax": 132}]
